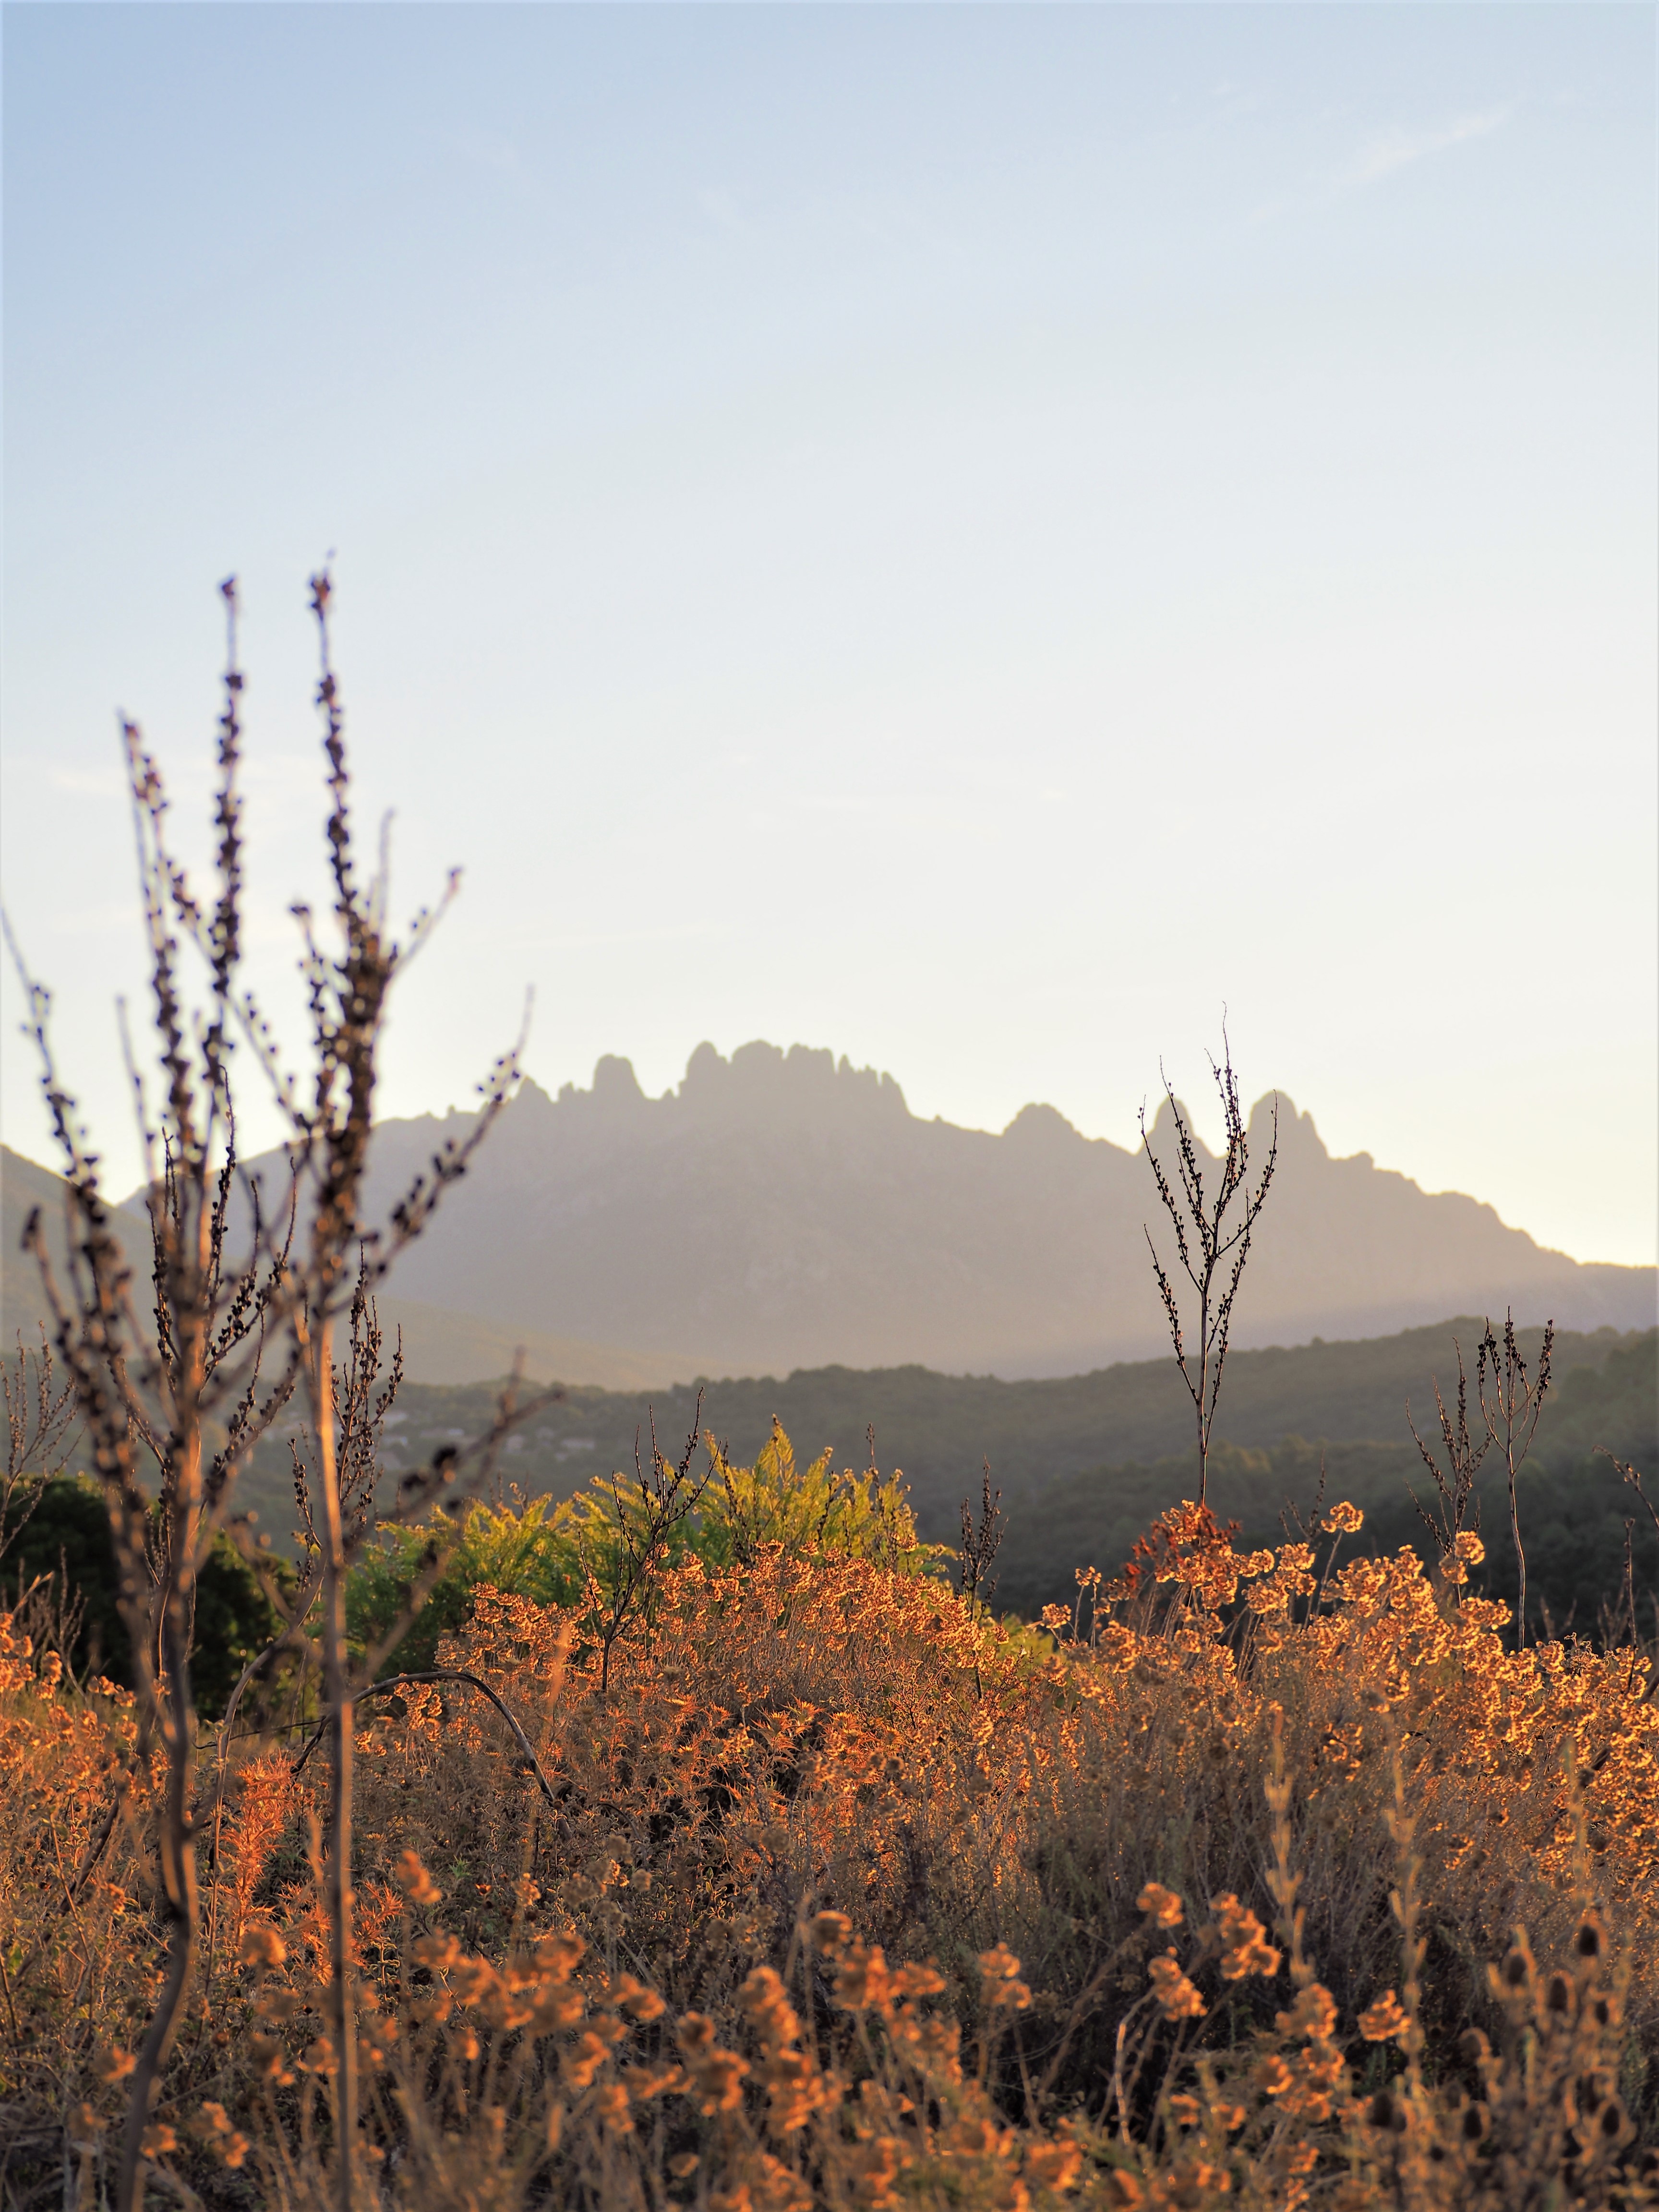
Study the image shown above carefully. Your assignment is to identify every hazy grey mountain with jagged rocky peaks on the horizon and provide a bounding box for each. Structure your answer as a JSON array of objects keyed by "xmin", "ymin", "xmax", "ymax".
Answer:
[{"xmin": 149, "ymin": 1044, "xmax": 1657, "ymax": 1376}]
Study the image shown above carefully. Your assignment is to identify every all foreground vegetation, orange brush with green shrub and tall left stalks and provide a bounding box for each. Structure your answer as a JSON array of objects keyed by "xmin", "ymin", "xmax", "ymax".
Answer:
[{"xmin": 0, "ymin": 579, "xmax": 1659, "ymax": 2212}]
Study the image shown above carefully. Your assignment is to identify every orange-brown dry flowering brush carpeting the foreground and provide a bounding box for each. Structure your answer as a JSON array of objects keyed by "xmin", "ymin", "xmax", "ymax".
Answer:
[{"xmin": 0, "ymin": 1506, "xmax": 1659, "ymax": 2212}]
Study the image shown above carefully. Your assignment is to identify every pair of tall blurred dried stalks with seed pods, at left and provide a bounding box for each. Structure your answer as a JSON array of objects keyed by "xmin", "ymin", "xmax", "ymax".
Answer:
[{"xmin": 7, "ymin": 571, "xmax": 533, "ymax": 2212}]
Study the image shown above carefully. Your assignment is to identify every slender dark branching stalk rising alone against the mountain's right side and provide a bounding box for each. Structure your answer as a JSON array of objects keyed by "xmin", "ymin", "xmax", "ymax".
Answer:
[{"xmin": 1142, "ymin": 1031, "xmax": 1278, "ymax": 1504}]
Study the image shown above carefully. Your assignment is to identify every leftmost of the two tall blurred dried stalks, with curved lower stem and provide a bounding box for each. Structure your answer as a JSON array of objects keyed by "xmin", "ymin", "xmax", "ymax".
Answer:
[{"xmin": 13, "ymin": 584, "xmax": 294, "ymax": 2212}]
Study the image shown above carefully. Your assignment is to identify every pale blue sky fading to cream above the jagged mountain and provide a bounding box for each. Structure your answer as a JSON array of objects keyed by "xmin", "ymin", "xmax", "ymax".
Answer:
[{"xmin": 0, "ymin": 4, "xmax": 1659, "ymax": 1265}]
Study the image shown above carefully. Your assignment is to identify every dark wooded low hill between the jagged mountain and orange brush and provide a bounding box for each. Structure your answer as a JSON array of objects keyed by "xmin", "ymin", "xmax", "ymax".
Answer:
[{"xmin": 318, "ymin": 1318, "xmax": 1659, "ymax": 1633}]
